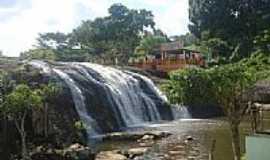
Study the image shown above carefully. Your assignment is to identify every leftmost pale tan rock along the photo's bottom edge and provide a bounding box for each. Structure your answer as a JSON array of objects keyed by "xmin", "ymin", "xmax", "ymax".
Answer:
[{"xmin": 96, "ymin": 151, "xmax": 127, "ymax": 160}]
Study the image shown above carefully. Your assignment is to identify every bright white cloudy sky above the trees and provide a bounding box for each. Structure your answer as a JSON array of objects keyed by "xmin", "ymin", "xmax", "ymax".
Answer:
[{"xmin": 0, "ymin": 0, "xmax": 189, "ymax": 56}]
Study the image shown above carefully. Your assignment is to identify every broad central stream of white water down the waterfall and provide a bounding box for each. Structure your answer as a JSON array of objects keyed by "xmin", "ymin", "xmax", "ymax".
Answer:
[{"xmin": 82, "ymin": 63, "xmax": 160, "ymax": 126}]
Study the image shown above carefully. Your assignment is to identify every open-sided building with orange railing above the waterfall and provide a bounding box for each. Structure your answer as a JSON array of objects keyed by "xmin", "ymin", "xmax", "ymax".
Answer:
[{"xmin": 132, "ymin": 41, "xmax": 205, "ymax": 73}]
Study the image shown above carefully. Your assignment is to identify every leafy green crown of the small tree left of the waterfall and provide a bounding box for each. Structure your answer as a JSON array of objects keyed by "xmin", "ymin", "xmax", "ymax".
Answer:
[{"xmin": 0, "ymin": 84, "xmax": 42, "ymax": 119}]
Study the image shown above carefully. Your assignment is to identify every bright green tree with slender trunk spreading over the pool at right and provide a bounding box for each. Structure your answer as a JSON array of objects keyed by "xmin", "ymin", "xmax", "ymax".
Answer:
[{"xmin": 164, "ymin": 54, "xmax": 270, "ymax": 160}]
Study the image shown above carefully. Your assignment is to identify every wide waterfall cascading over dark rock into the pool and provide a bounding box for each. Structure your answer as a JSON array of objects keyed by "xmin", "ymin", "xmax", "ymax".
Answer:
[{"xmin": 30, "ymin": 61, "xmax": 172, "ymax": 141}]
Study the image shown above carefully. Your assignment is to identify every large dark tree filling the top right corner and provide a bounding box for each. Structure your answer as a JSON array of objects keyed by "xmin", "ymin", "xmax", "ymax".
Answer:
[{"xmin": 189, "ymin": 0, "xmax": 270, "ymax": 58}]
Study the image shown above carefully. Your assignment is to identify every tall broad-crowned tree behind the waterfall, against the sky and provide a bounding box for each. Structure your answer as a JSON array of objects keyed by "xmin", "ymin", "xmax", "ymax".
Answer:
[{"xmin": 72, "ymin": 4, "xmax": 155, "ymax": 62}]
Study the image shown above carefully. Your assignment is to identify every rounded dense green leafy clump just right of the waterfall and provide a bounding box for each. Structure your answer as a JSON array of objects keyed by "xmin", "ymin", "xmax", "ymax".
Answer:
[{"xmin": 162, "ymin": 68, "xmax": 211, "ymax": 105}]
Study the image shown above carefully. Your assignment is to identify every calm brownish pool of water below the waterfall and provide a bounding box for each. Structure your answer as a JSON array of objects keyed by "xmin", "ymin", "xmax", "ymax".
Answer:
[{"xmin": 96, "ymin": 118, "xmax": 270, "ymax": 160}]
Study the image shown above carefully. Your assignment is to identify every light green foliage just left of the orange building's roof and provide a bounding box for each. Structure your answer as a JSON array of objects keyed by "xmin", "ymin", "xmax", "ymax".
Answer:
[{"xmin": 135, "ymin": 35, "xmax": 167, "ymax": 55}]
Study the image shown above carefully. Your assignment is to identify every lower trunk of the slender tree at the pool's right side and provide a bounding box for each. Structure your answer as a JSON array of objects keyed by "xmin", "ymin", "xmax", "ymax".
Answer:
[{"xmin": 231, "ymin": 122, "xmax": 241, "ymax": 160}]
